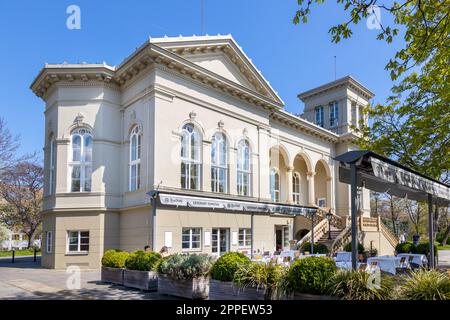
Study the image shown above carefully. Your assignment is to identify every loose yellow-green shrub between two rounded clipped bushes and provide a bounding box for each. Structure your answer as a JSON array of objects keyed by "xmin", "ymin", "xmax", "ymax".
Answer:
[{"xmin": 233, "ymin": 262, "xmax": 285, "ymax": 299}]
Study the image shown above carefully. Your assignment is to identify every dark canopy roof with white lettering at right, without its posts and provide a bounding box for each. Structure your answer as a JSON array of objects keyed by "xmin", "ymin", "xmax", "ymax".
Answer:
[{"xmin": 334, "ymin": 150, "xmax": 450, "ymax": 206}]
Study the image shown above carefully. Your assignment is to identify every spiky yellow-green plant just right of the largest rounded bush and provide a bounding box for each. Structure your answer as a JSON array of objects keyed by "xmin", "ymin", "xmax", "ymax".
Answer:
[{"xmin": 327, "ymin": 270, "xmax": 393, "ymax": 300}]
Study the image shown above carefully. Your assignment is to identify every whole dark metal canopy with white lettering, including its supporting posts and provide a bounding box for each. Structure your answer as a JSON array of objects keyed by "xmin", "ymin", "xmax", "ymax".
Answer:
[{"xmin": 334, "ymin": 150, "xmax": 450, "ymax": 270}]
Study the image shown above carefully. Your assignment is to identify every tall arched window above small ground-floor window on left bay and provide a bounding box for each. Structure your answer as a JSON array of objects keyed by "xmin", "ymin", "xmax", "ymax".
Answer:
[{"xmin": 69, "ymin": 128, "xmax": 92, "ymax": 192}]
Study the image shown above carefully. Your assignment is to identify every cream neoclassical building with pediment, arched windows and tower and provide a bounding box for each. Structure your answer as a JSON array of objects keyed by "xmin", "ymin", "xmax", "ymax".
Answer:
[{"xmin": 31, "ymin": 36, "xmax": 395, "ymax": 268}]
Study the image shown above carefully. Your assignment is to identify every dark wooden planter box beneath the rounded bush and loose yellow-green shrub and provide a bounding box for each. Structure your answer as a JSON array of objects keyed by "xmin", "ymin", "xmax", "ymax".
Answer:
[{"xmin": 209, "ymin": 279, "xmax": 264, "ymax": 300}]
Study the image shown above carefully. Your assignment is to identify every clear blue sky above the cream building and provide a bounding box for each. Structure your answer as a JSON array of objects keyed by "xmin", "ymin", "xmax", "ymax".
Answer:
[{"xmin": 0, "ymin": 0, "xmax": 402, "ymax": 158}]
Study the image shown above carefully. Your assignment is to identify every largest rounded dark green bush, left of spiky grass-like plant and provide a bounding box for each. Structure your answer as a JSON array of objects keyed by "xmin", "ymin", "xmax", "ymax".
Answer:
[{"xmin": 282, "ymin": 257, "xmax": 337, "ymax": 294}]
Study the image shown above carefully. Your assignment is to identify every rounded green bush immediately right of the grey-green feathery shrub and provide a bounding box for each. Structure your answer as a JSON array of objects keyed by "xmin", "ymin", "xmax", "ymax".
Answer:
[{"xmin": 211, "ymin": 252, "xmax": 250, "ymax": 281}]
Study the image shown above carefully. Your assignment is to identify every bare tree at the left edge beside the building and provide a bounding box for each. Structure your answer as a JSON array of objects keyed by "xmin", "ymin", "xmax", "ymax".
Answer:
[{"xmin": 0, "ymin": 161, "xmax": 44, "ymax": 247}]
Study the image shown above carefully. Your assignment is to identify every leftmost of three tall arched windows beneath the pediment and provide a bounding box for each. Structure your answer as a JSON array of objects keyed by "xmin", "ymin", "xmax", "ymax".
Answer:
[{"xmin": 181, "ymin": 123, "xmax": 202, "ymax": 190}]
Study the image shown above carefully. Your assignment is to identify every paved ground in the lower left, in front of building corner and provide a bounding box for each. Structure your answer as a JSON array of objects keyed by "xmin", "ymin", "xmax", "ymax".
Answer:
[{"xmin": 0, "ymin": 257, "xmax": 178, "ymax": 300}]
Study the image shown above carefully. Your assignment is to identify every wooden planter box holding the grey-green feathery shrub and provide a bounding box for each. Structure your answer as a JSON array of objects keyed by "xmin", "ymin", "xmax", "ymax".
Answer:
[{"xmin": 158, "ymin": 274, "xmax": 209, "ymax": 299}]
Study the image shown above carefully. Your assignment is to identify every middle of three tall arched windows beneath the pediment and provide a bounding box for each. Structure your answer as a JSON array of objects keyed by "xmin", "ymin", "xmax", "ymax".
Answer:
[{"xmin": 211, "ymin": 132, "xmax": 228, "ymax": 192}]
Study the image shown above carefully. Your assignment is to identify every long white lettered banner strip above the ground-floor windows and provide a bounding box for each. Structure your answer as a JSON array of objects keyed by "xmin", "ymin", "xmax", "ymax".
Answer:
[{"xmin": 159, "ymin": 194, "xmax": 315, "ymax": 215}]
